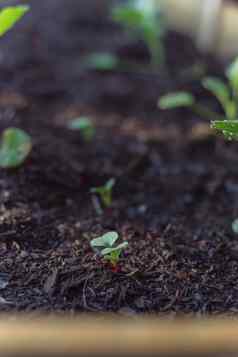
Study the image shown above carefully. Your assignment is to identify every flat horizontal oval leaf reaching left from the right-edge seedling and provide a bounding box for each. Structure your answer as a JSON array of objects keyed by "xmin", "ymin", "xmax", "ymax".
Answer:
[{"xmin": 159, "ymin": 92, "xmax": 195, "ymax": 110}]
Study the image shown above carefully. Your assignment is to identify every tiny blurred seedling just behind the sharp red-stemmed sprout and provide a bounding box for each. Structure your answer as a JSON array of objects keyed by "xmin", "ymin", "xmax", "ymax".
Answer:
[{"xmin": 91, "ymin": 178, "xmax": 116, "ymax": 214}]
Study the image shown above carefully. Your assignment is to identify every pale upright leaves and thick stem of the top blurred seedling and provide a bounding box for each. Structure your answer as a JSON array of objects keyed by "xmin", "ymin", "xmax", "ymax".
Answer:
[{"xmin": 112, "ymin": 0, "xmax": 166, "ymax": 69}]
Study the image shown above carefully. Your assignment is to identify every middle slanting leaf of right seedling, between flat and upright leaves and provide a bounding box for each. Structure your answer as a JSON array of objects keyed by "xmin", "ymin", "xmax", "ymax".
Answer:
[{"xmin": 202, "ymin": 77, "xmax": 230, "ymax": 111}]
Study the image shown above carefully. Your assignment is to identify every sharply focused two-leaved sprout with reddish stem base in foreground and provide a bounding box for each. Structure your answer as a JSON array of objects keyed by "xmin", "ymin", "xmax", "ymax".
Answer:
[{"xmin": 90, "ymin": 232, "xmax": 128, "ymax": 267}]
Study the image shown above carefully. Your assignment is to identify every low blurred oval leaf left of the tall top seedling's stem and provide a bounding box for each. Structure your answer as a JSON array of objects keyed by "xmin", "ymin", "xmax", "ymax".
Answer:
[{"xmin": 83, "ymin": 52, "xmax": 119, "ymax": 71}]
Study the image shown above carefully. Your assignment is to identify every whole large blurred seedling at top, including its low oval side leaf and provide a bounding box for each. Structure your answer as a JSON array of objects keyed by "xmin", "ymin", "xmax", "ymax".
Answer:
[{"xmin": 82, "ymin": 0, "xmax": 167, "ymax": 72}]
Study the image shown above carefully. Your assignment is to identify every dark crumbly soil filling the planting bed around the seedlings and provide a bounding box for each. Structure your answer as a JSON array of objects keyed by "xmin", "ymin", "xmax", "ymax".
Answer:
[{"xmin": 0, "ymin": 0, "xmax": 238, "ymax": 316}]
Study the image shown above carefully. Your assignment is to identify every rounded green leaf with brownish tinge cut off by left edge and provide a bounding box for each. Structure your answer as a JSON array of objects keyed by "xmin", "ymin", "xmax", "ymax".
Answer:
[{"xmin": 0, "ymin": 128, "xmax": 32, "ymax": 168}]
